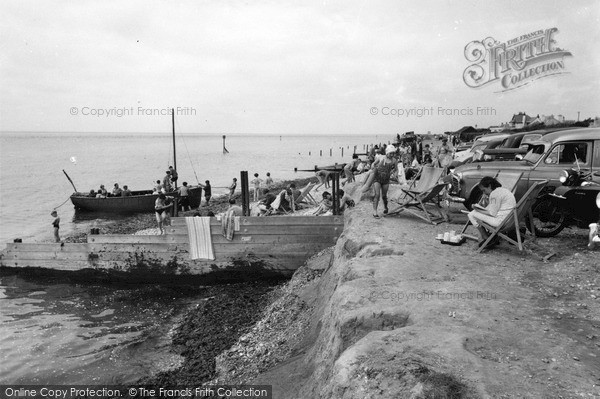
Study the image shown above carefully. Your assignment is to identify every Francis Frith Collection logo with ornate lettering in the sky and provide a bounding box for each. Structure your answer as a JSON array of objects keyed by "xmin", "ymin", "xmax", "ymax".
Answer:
[{"xmin": 463, "ymin": 28, "xmax": 572, "ymax": 91}]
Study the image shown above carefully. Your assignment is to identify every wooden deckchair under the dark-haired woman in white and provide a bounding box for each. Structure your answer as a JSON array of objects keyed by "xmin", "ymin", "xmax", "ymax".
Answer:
[{"xmin": 477, "ymin": 180, "xmax": 548, "ymax": 252}]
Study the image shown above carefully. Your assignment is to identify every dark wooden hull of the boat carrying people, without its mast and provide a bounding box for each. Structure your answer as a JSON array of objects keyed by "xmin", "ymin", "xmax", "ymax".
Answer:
[{"xmin": 71, "ymin": 187, "xmax": 202, "ymax": 213}]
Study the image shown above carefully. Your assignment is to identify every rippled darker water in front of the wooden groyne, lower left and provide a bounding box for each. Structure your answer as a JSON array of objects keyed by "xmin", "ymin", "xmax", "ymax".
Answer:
[{"xmin": 0, "ymin": 276, "xmax": 199, "ymax": 384}]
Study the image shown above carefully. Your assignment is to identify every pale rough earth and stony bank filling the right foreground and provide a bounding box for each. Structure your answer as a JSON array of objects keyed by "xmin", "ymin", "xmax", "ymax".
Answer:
[{"xmin": 207, "ymin": 182, "xmax": 600, "ymax": 398}]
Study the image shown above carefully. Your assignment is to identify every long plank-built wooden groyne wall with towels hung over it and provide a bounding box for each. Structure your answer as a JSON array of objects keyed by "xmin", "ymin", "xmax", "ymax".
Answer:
[{"xmin": 0, "ymin": 216, "xmax": 344, "ymax": 274}]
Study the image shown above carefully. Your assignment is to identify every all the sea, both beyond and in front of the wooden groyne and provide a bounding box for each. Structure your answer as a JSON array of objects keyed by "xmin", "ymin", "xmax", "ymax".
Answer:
[{"xmin": 0, "ymin": 132, "xmax": 384, "ymax": 384}]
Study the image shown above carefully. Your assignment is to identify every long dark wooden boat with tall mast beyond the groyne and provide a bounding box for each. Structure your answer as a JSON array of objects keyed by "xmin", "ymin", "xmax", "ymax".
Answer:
[{"xmin": 63, "ymin": 110, "xmax": 202, "ymax": 214}]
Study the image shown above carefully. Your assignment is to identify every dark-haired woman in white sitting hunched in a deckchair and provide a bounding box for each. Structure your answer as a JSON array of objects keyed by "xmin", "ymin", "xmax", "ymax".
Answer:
[{"xmin": 469, "ymin": 176, "xmax": 517, "ymax": 245}]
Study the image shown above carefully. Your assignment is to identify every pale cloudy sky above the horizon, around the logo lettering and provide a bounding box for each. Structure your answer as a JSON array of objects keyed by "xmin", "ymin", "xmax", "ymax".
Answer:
[{"xmin": 0, "ymin": 0, "xmax": 600, "ymax": 134}]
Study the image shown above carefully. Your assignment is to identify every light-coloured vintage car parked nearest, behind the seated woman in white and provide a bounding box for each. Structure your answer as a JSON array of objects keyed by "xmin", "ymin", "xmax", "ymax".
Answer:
[{"xmin": 450, "ymin": 128, "xmax": 600, "ymax": 209}]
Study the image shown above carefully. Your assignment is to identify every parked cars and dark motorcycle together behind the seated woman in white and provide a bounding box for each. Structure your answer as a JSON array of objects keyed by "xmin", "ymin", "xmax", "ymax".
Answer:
[{"xmin": 449, "ymin": 128, "xmax": 600, "ymax": 237}]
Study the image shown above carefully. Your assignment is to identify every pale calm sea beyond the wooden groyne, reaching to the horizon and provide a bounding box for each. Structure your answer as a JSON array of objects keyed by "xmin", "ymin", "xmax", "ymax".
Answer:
[{"xmin": 0, "ymin": 133, "xmax": 382, "ymax": 243}]
